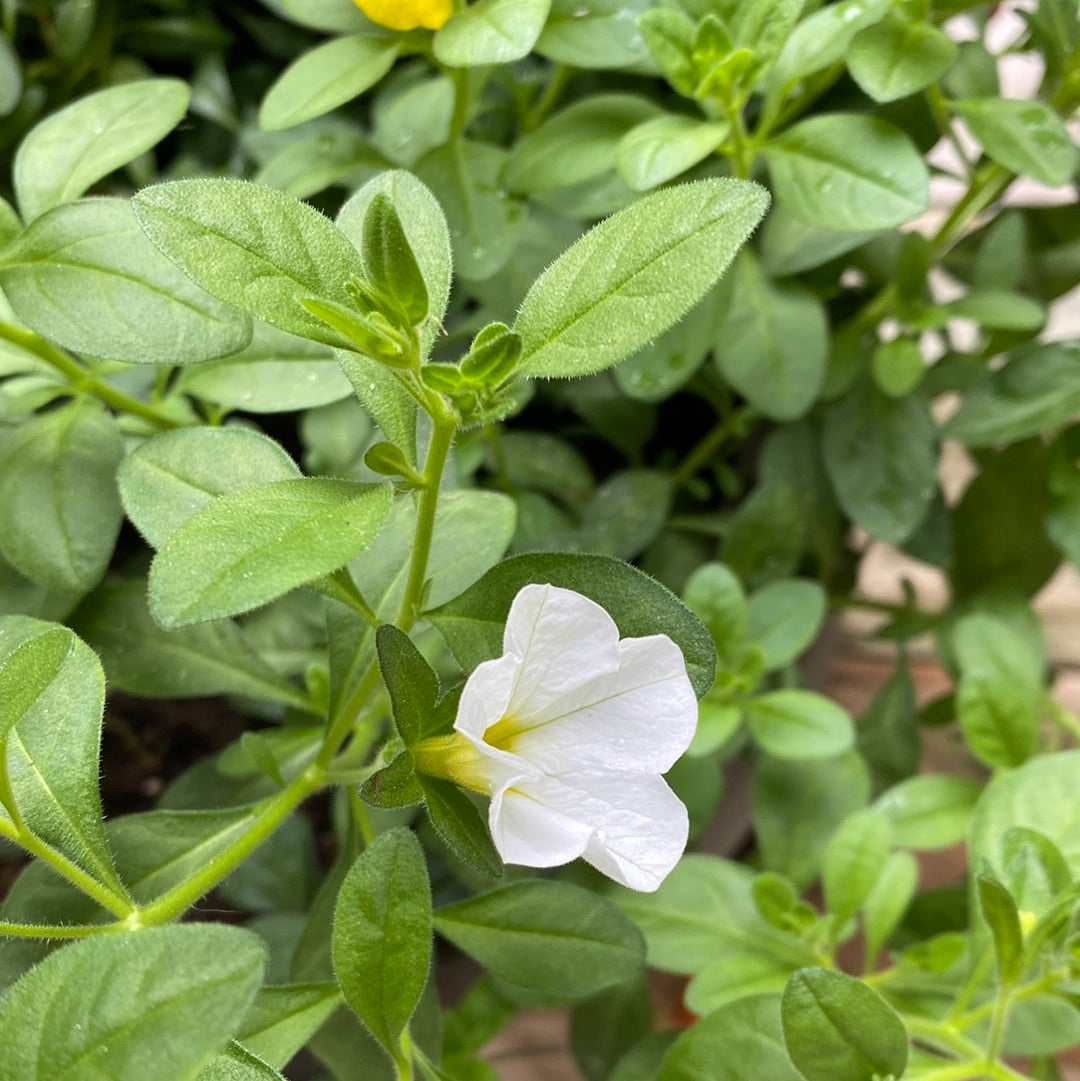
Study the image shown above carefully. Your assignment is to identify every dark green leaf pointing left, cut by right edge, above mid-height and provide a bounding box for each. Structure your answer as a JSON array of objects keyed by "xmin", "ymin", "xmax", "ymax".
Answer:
[{"xmin": 943, "ymin": 342, "xmax": 1080, "ymax": 446}]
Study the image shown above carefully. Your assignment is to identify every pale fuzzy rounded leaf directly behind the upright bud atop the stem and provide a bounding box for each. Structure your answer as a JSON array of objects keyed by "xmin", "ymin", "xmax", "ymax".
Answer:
[{"xmin": 336, "ymin": 169, "xmax": 453, "ymax": 332}]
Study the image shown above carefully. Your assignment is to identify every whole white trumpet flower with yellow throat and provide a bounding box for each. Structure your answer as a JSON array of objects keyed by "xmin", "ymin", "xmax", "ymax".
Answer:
[{"xmin": 416, "ymin": 585, "xmax": 697, "ymax": 891}]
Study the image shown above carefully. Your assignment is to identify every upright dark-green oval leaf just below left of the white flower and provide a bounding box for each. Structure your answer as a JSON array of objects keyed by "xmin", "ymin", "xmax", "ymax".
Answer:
[{"xmin": 333, "ymin": 829, "xmax": 431, "ymax": 1059}]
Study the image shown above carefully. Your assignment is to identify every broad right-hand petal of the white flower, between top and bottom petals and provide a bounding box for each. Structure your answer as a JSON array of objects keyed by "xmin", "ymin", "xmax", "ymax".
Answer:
[{"xmin": 507, "ymin": 635, "xmax": 697, "ymax": 775}]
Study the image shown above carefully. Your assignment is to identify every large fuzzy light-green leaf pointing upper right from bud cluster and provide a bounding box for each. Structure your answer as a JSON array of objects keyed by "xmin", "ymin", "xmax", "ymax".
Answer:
[{"xmin": 514, "ymin": 179, "xmax": 766, "ymax": 377}]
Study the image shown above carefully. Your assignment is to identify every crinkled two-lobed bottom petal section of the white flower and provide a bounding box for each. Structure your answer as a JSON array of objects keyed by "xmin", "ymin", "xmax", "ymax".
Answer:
[{"xmin": 489, "ymin": 774, "xmax": 690, "ymax": 892}]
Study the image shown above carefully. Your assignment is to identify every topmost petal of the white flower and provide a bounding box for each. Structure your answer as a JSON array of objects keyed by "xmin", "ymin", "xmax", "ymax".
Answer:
[{"xmin": 503, "ymin": 585, "xmax": 618, "ymax": 719}]
